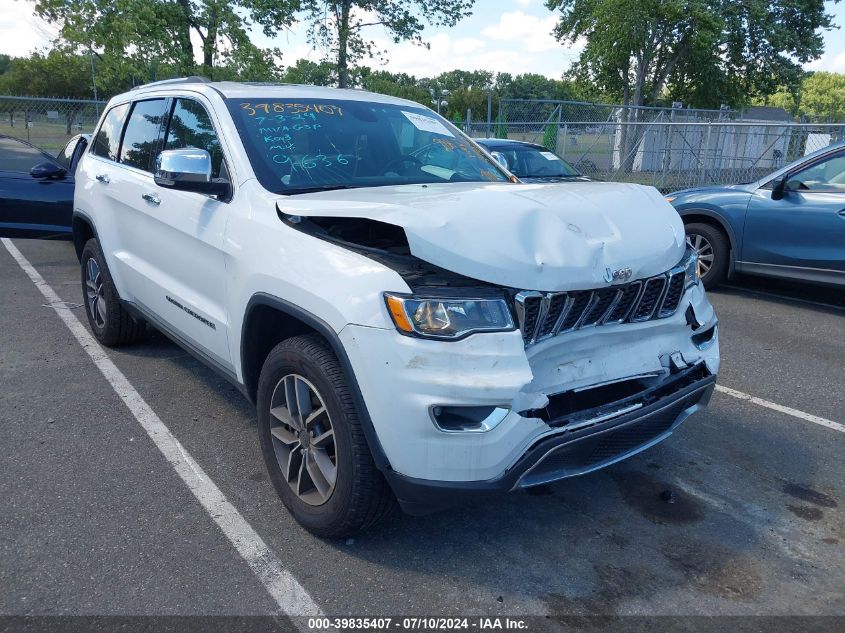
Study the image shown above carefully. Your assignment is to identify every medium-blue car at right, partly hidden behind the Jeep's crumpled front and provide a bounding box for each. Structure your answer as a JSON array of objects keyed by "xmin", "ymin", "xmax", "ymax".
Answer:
[{"xmin": 666, "ymin": 143, "xmax": 845, "ymax": 288}]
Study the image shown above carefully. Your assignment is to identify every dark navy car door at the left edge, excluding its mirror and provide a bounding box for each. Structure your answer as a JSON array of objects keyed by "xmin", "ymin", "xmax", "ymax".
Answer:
[{"xmin": 0, "ymin": 136, "xmax": 74, "ymax": 238}]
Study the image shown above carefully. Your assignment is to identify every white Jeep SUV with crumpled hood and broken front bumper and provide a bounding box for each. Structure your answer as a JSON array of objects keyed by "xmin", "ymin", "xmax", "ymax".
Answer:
[{"xmin": 73, "ymin": 78, "xmax": 719, "ymax": 537}]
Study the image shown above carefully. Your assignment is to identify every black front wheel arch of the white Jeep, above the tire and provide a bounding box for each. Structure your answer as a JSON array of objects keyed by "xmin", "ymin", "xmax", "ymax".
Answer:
[{"xmin": 240, "ymin": 293, "xmax": 390, "ymax": 472}]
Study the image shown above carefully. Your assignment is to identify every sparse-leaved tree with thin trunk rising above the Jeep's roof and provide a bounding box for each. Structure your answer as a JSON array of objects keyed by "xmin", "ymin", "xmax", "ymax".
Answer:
[{"xmin": 292, "ymin": 0, "xmax": 475, "ymax": 88}]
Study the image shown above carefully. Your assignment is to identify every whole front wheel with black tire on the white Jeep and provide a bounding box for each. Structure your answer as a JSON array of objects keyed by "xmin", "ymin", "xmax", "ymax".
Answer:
[{"xmin": 257, "ymin": 334, "xmax": 395, "ymax": 538}]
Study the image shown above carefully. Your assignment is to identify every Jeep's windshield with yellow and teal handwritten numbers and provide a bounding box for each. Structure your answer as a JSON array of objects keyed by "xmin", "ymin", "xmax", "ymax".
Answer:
[{"xmin": 227, "ymin": 99, "xmax": 508, "ymax": 194}]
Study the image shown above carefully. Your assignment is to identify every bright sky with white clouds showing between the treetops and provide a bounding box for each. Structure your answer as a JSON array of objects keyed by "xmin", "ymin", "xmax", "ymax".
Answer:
[{"xmin": 0, "ymin": 0, "xmax": 845, "ymax": 78}]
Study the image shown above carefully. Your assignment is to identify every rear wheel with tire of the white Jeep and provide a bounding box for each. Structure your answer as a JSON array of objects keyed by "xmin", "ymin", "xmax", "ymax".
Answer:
[{"xmin": 80, "ymin": 237, "xmax": 146, "ymax": 347}]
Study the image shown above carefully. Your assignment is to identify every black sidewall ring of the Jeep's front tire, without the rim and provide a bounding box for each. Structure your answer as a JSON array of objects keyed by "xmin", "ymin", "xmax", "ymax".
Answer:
[{"xmin": 257, "ymin": 344, "xmax": 360, "ymax": 534}]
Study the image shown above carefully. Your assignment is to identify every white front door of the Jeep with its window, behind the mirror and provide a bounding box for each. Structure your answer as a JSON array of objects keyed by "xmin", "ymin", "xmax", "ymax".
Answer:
[{"xmin": 111, "ymin": 99, "xmax": 232, "ymax": 371}]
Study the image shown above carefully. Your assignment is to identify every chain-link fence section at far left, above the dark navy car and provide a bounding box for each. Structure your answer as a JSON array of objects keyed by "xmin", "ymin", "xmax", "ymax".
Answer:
[{"xmin": 0, "ymin": 96, "xmax": 105, "ymax": 154}]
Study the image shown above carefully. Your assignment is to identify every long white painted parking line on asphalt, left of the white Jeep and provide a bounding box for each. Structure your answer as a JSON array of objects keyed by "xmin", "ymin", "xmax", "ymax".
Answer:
[{"xmin": 0, "ymin": 238, "xmax": 322, "ymax": 616}]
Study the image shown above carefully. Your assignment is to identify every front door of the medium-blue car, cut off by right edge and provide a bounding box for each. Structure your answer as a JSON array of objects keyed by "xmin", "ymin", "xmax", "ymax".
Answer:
[{"xmin": 741, "ymin": 150, "xmax": 845, "ymax": 283}]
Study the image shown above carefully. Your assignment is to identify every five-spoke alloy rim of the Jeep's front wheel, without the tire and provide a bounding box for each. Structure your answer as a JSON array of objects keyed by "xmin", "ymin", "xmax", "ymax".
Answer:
[{"xmin": 270, "ymin": 374, "xmax": 337, "ymax": 506}]
